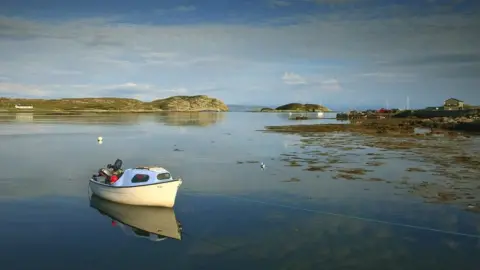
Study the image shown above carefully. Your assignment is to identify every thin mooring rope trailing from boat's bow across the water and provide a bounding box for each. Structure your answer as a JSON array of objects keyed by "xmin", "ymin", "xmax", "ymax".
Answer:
[{"xmin": 181, "ymin": 192, "xmax": 480, "ymax": 239}]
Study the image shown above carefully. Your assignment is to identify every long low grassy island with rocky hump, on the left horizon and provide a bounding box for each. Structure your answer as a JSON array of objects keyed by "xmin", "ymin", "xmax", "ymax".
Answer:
[{"xmin": 0, "ymin": 95, "xmax": 229, "ymax": 114}]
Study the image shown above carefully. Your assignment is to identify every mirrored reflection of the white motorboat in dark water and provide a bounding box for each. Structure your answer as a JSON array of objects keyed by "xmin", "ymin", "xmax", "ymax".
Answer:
[{"xmin": 90, "ymin": 195, "xmax": 182, "ymax": 241}]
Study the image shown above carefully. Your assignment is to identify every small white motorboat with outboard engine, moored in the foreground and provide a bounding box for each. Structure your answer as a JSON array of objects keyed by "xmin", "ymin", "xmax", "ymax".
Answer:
[{"xmin": 89, "ymin": 159, "xmax": 182, "ymax": 207}]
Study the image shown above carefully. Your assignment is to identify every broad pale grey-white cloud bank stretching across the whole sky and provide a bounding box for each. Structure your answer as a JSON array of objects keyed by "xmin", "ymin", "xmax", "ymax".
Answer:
[{"xmin": 0, "ymin": 1, "xmax": 480, "ymax": 103}]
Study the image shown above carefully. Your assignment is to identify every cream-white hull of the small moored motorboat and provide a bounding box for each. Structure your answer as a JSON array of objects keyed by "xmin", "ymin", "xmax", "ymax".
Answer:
[{"xmin": 89, "ymin": 179, "xmax": 182, "ymax": 208}]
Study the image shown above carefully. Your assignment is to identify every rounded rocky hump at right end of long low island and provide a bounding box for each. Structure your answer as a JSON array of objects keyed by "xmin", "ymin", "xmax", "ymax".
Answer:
[{"xmin": 151, "ymin": 95, "xmax": 228, "ymax": 112}]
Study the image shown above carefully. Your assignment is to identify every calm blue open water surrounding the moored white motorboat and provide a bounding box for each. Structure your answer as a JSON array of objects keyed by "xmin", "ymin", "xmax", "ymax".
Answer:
[{"xmin": 0, "ymin": 113, "xmax": 480, "ymax": 270}]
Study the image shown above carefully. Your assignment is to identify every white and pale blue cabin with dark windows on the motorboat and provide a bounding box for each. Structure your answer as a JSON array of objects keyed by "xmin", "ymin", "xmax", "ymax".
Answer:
[{"xmin": 111, "ymin": 167, "xmax": 173, "ymax": 187}]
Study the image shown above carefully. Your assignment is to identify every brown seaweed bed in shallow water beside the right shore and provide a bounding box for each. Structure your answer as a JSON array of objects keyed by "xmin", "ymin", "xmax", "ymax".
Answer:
[{"xmin": 258, "ymin": 121, "xmax": 480, "ymax": 213}]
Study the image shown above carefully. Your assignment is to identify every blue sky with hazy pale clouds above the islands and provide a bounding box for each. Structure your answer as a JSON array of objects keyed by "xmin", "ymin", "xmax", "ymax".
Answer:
[{"xmin": 0, "ymin": 0, "xmax": 480, "ymax": 108}]
